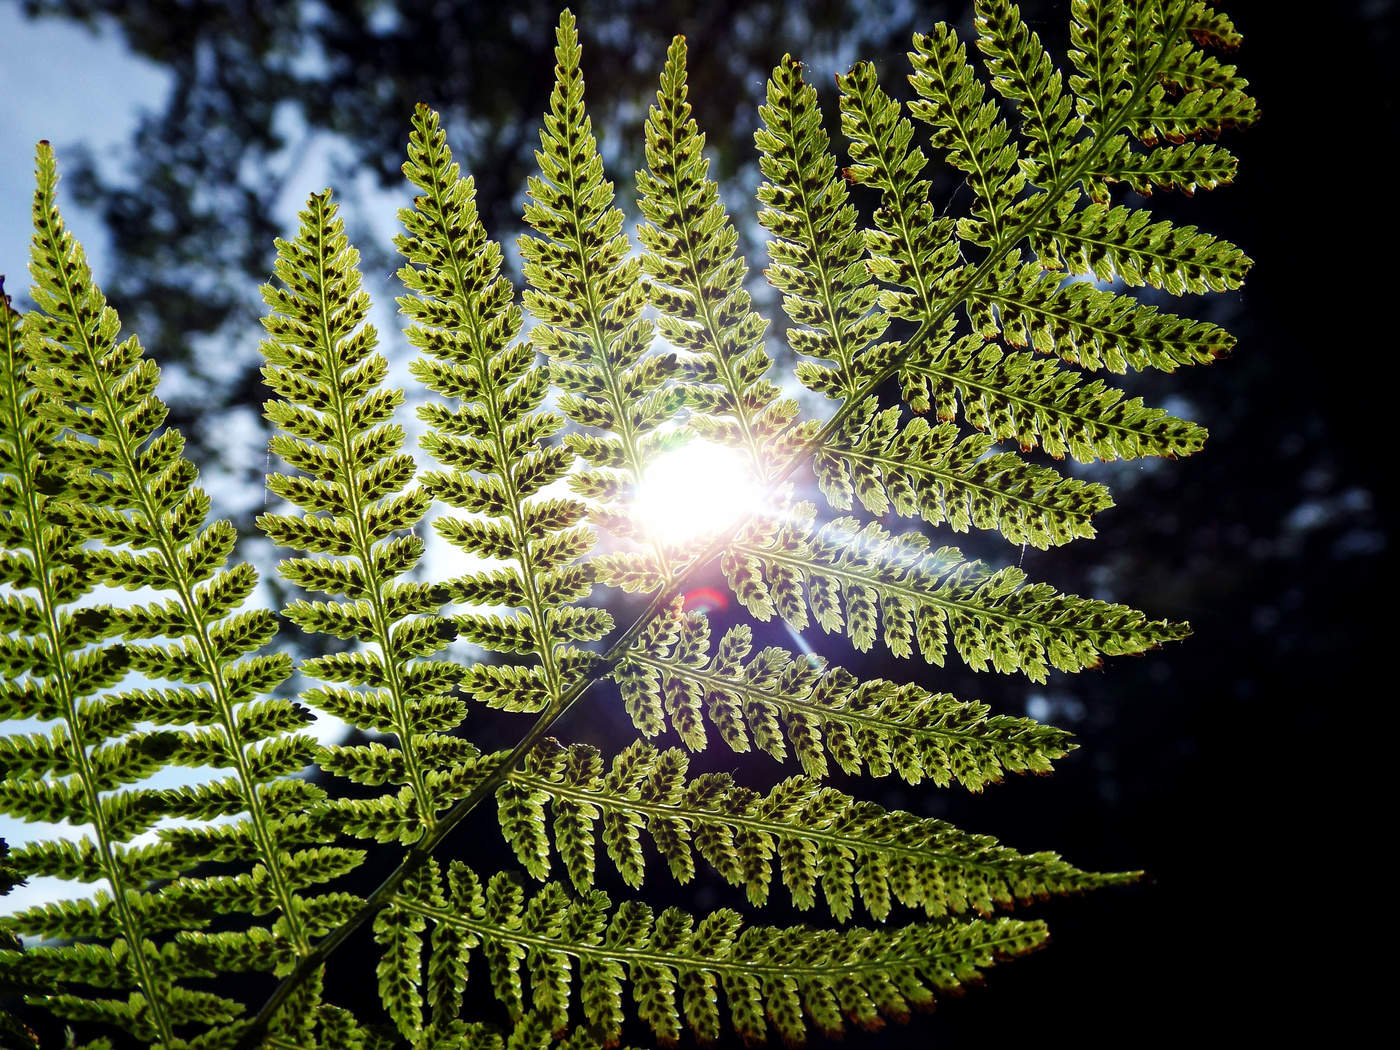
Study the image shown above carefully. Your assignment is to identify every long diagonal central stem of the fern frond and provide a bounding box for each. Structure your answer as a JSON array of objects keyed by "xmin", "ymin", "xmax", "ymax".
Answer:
[{"xmin": 234, "ymin": 6, "xmax": 1189, "ymax": 1050}]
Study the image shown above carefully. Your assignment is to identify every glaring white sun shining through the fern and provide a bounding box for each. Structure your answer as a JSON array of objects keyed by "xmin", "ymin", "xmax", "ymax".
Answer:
[{"xmin": 636, "ymin": 438, "xmax": 760, "ymax": 543}]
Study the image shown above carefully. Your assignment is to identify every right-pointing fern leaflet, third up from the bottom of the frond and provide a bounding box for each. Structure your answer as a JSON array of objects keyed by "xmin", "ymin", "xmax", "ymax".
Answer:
[{"xmin": 613, "ymin": 602, "xmax": 1074, "ymax": 791}]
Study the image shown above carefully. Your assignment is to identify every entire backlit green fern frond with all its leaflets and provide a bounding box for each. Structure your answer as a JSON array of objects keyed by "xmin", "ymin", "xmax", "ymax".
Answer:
[{"xmin": 0, "ymin": 0, "xmax": 1254, "ymax": 1050}]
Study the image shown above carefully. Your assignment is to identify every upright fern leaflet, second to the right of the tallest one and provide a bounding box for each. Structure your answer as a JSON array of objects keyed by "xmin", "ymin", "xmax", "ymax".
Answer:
[{"xmin": 753, "ymin": 55, "xmax": 893, "ymax": 400}]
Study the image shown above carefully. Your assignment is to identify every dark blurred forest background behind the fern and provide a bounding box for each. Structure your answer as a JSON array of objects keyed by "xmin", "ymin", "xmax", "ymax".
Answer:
[{"xmin": 2, "ymin": 0, "xmax": 1396, "ymax": 1047}]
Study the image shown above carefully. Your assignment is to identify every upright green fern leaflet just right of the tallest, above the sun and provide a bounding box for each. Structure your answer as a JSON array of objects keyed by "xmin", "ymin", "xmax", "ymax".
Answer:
[{"xmin": 637, "ymin": 36, "xmax": 797, "ymax": 477}]
